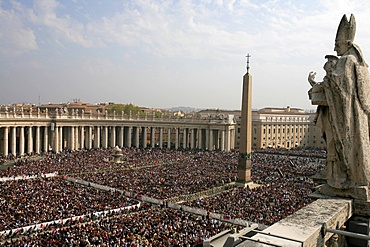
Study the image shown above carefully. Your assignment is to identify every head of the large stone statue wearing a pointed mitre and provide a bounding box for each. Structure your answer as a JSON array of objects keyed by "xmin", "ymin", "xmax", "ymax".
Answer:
[{"xmin": 334, "ymin": 14, "xmax": 356, "ymax": 56}]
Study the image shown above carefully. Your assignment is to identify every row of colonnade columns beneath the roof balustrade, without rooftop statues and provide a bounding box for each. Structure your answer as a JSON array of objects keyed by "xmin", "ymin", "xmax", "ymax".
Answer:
[{"xmin": 0, "ymin": 122, "xmax": 235, "ymax": 155}]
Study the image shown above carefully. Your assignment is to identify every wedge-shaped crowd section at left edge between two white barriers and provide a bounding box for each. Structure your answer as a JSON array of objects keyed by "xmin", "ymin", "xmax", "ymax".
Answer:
[{"xmin": 0, "ymin": 177, "xmax": 138, "ymax": 231}]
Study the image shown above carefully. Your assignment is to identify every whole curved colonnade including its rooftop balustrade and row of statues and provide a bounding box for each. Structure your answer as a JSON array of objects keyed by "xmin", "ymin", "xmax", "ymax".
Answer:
[{"xmin": 0, "ymin": 107, "xmax": 236, "ymax": 155}]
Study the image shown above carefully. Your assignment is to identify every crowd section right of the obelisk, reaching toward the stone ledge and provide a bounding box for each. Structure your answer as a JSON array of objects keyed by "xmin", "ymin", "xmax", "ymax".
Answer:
[{"xmin": 185, "ymin": 153, "xmax": 323, "ymax": 225}]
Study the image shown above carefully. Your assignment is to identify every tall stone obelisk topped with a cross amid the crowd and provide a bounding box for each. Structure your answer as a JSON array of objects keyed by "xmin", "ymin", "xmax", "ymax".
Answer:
[{"xmin": 237, "ymin": 53, "xmax": 252, "ymax": 185}]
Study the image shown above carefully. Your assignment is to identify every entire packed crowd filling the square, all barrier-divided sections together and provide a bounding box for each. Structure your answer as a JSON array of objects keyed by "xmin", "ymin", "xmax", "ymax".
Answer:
[{"xmin": 0, "ymin": 148, "xmax": 323, "ymax": 246}]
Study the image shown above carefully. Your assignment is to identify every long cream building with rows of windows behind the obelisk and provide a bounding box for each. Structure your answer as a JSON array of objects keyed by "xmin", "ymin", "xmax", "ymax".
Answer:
[{"xmin": 198, "ymin": 106, "xmax": 325, "ymax": 149}]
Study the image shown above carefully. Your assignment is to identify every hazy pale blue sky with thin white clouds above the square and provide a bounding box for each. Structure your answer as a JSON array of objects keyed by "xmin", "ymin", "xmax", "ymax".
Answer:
[{"xmin": 0, "ymin": 0, "xmax": 370, "ymax": 110}]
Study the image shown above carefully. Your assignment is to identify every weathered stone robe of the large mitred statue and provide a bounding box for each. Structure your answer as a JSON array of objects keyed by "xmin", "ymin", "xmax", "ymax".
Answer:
[{"xmin": 324, "ymin": 45, "xmax": 370, "ymax": 189}]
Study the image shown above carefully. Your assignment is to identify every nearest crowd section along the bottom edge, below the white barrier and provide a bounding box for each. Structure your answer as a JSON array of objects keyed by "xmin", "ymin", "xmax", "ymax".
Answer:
[{"xmin": 4, "ymin": 204, "xmax": 232, "ymax": 247}]
